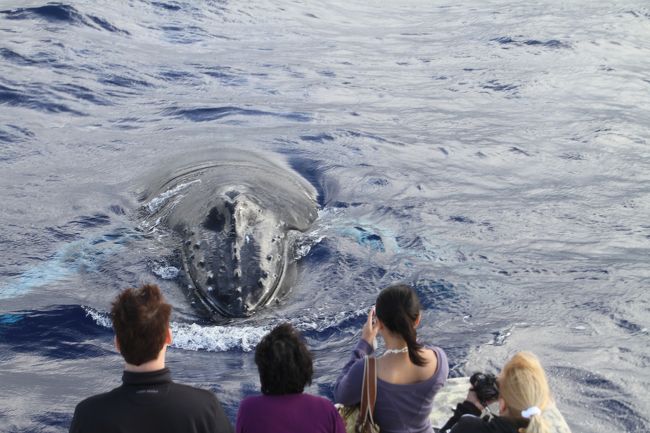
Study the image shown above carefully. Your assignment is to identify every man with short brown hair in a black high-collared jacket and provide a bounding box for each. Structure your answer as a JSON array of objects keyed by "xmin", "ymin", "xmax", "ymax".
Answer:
[{"xmin": 70, "ymin": 284, "xmax": 233, "ymax": 433}]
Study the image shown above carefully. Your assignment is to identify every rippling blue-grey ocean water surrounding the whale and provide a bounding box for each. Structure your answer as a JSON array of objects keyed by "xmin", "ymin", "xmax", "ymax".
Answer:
[{"xmin": 0, "ymin": 0, "xmax": 650, "ymax": 433}]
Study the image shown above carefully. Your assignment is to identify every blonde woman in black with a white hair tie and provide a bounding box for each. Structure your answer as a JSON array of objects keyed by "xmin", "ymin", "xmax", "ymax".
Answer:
[{"xmin": 442, "ymin": 352, "xmax": 551, "ymax": 433}]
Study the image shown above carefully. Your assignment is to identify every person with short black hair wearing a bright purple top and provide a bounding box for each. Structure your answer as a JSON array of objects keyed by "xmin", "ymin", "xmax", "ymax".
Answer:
[{"xmin": 236, "ymin": 323, "xmax": 345, "ymax": 433}]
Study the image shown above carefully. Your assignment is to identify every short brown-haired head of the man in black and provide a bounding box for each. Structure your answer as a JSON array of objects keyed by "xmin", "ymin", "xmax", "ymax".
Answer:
[{"xmin": 111, "ymin": 284, "xmax": 172, "ymax": 366}]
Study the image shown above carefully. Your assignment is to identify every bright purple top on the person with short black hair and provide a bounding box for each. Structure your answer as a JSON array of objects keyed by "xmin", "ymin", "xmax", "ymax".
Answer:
[{"xmin": 236, "ymin": 394, "xmax": 345, "ymax": 433}]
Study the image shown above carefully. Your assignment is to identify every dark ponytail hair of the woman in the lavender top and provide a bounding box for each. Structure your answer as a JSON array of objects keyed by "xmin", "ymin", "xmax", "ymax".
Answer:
[{"xmin": 375, "ymin": 284, "xmax": 426, "ymax": 366}]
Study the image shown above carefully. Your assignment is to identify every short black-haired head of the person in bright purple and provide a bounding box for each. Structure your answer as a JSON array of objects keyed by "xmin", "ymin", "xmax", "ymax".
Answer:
[{"xmin": 255, "ymin": 323, "xmax": 314, "ymax": 395}]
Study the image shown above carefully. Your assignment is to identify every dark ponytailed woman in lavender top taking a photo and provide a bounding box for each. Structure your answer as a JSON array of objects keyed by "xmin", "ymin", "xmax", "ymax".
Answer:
[{"xmin": 334, "ymin": 284, "xmax": 449, "ymax": 433}]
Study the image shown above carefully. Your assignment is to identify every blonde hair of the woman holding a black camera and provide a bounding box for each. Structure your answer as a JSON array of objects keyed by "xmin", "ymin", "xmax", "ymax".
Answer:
[{"xmin": 498, "ymin": 352, "xmax": 551, "ymax": 433}]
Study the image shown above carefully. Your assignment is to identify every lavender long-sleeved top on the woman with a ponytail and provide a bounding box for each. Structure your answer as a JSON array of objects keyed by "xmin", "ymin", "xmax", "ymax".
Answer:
[{"xmin": 334, "ymin": 340, "xmax": 449, "ymax": 433}]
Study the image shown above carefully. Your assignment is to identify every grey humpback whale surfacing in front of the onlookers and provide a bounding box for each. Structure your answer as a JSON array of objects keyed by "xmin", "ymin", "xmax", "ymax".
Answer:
[{"xmin": 141, "ymin": 150, "xmax": 318, "ymax": 318}]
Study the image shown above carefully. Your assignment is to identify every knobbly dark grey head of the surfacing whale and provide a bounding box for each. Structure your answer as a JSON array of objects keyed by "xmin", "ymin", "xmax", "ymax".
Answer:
[{"xmin": 182, "ymin": 194, "xmax": 287, "ymax": 317}]
